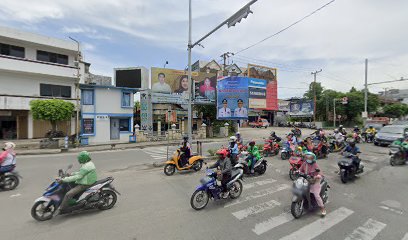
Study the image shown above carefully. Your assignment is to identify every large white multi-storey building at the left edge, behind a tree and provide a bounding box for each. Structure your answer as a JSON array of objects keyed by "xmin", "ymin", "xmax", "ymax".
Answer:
[{"xmin": 0, "ymin": 27, "xmax": 89, "ymax": 139}]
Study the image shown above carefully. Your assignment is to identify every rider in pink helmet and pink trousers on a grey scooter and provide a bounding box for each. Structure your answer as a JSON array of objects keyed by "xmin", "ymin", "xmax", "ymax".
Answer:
[{"xmin": 299, "ymin": 152, "xmax": 326, "ymax": 216}]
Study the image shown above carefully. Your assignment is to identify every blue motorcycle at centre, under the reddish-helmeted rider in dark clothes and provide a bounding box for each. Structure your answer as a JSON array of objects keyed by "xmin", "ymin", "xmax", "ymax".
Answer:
[{"xmin": 190, "ymin": 168, "xmax": 244, "ymax": 210}]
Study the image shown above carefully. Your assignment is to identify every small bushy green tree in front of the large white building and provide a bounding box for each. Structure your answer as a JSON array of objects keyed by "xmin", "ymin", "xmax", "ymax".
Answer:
[{"xmin": 30, "ymin": 99, "xmax": 75, "ymax": 131}]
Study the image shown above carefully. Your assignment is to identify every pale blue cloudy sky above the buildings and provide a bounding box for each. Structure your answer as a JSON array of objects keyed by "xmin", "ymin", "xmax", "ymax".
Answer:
[{"xmin": 0, "ymin": 0, "xmax": 408, "ymax": 98}]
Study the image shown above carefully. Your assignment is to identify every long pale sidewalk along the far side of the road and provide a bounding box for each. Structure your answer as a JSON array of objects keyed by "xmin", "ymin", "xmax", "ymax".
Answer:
[{"xmin": 16, "ymin": 138, "xmax": 228, "ymax": 155}]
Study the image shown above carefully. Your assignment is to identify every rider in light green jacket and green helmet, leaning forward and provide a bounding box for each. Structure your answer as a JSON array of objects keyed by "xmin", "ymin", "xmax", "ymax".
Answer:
[{"xmin": 55, "ymin": 151, "xmax": 97, "ymax": 215}]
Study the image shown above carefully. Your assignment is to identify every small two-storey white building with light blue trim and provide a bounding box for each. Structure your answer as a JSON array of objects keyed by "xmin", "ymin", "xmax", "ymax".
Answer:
[{"xmin": 80, "ymin": 84, "xmax": 136, "ymax": 144}]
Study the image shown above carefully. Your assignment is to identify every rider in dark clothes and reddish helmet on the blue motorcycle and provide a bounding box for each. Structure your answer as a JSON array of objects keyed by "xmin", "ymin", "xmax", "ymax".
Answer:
[{"xmin": 208, "ymin": 149, "xmax": 232, "ymax": 198}]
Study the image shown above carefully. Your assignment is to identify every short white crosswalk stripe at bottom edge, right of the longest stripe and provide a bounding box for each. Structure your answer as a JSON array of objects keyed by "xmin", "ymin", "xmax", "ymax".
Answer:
[{"xmin": 345, "ymin": 218, "xmax": 387, "ymax": 240}]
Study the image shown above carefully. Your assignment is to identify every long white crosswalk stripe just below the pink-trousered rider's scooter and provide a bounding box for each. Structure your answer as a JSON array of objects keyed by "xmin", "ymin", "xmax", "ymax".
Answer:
[{"xmin": 280, "ymin": 207, "xmax": 354, "ymax": 240}]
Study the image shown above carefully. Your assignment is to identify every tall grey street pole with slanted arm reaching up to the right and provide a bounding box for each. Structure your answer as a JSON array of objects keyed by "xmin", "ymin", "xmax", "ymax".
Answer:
[{"xmin": 187, "ymin": 0, "xmax": 258, "ymax": 141}]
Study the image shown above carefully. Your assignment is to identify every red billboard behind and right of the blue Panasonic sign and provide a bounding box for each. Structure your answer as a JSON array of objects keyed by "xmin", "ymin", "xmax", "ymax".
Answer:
[{"xmin": 248, "ymin": 64, "xmax": 278, "ymax": 110}]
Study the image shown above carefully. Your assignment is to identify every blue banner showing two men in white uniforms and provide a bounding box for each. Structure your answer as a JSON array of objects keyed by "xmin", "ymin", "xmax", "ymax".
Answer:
[{"xmin": 217, "ymin": 77, "xmax": 248, "ymax": 120}]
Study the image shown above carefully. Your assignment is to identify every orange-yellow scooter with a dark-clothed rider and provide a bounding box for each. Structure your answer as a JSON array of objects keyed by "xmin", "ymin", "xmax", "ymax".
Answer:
[{"xmin": 164, "ymin": 149, "xmax": 204, "ymax": 176}]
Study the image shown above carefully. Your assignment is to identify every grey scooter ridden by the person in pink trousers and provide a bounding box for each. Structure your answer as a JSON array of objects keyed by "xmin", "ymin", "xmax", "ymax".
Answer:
[{"xmin": 290, "ymin": 173, "xmax": 330, "ymax": 218}]
